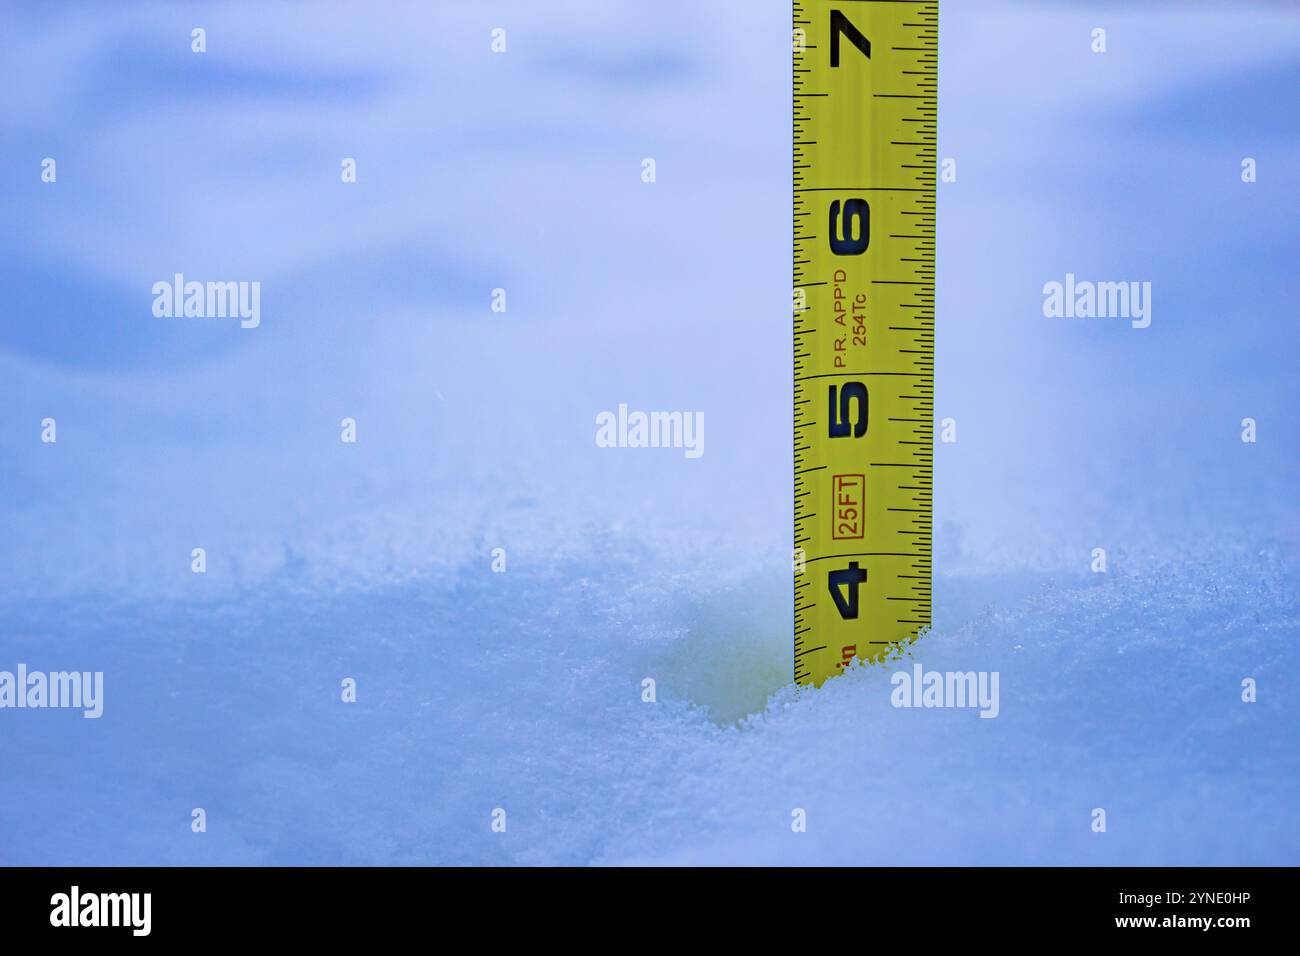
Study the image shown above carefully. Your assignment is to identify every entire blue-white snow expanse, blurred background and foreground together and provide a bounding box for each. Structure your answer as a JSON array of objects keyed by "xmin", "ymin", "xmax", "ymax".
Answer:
[{"xmin": 0, "ymin": 3, "xmax": 1300, "ymax": 865}]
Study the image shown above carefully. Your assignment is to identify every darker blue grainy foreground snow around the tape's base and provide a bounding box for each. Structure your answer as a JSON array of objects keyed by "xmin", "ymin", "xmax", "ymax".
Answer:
[{"xmin": 0, "ymin": 535, "xmax": 1300, "ymax": 865}]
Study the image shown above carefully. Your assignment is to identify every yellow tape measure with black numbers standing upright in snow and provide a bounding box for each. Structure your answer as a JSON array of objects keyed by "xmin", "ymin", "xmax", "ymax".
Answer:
[{"xmin": 794, "ymin": 0, "xmax": 939, "ymax": 684}]
